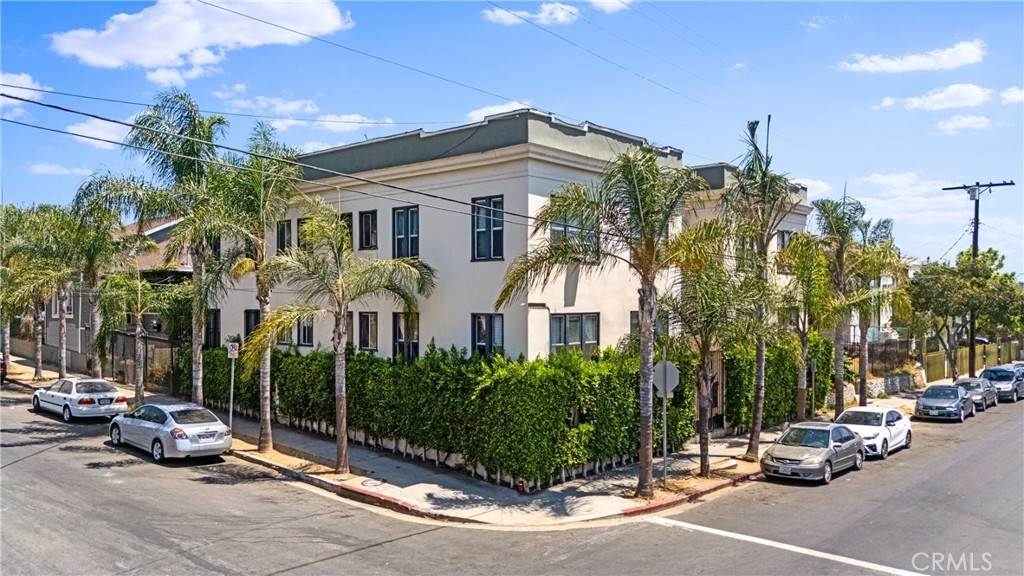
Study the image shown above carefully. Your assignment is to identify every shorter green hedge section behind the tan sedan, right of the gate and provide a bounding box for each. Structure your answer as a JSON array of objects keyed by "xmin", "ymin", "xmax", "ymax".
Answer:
[{"xmin": 725, "ymin": 333, "xmax": 834, "ymax": 427}]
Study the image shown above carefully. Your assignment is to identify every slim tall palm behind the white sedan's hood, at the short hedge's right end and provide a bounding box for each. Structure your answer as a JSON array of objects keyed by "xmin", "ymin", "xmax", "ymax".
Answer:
[{"xmin": 811, "ymin": 194, "xmax": 864, "ymax": 418}]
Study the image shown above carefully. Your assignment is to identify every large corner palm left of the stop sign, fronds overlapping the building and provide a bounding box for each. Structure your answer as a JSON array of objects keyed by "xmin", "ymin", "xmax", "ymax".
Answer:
[{"xmin": 495, "ymin": 147, "xmax": 708, "ymax": 498}]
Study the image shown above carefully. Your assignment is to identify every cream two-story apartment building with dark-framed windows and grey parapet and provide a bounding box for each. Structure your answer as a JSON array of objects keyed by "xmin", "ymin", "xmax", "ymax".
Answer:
[{"xmin": 220, "ymin": 110, "xmax": 809, "ymax": 366}]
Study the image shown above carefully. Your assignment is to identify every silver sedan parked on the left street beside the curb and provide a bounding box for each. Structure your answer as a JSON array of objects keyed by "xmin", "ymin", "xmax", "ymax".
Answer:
[{"xmin": 110, "ymin": 403, "xmax": 231, "ymax": 462}]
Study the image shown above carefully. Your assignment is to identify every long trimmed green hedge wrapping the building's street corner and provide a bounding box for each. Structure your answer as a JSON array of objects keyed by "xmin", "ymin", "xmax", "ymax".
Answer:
[{"xmin": 181, "ymin": 342, "xmax": 696, "ymax": 482}]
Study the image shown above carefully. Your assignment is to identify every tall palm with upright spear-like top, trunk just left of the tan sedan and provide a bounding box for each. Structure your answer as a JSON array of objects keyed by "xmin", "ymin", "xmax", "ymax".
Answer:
[{"xmin": 720, "ymin": 116, "xmax": 800, "ymax": 460}]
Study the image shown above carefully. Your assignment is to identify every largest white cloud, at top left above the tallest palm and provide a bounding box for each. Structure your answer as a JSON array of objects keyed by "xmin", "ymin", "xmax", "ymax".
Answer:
[{"xmin": 50, "ymin": 0, "xmax": 354, "ymax": 86}]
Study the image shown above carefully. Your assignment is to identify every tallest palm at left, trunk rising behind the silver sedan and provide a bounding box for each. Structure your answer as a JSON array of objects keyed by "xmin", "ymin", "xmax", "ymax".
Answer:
[{"xmin": 125, "ymin": 90, "xmax": 231, "ymax": 404}]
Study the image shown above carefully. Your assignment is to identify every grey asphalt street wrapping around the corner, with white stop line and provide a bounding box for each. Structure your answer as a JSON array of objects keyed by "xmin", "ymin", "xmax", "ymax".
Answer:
[{"xmin": 0, "ymin": 386, "xmax": 1024, "ymax": 575}]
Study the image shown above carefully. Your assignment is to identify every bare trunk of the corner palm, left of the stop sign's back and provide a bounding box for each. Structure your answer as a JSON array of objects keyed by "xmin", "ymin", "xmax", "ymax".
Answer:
[{"xmin": 635, "ymin": 282, "xmax": 657, "ymax": 498}]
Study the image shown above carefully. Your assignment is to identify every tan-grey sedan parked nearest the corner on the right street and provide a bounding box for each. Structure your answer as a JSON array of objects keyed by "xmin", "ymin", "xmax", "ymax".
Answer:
[{"xmin": 761, "ymin": 422, "xmax": 865, "ymax": 484}]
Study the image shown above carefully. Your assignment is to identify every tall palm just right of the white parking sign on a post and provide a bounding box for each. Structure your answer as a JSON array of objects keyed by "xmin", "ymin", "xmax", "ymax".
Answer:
[{"xmin": 229, "ymin": 122, "xmax": 302, "ymax": 452}]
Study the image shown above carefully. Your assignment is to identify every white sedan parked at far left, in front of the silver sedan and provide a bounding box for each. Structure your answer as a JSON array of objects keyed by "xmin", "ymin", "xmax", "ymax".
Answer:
[{"xmin": 32, "ymin": 378, "xmax": 128, "ymax": 422}]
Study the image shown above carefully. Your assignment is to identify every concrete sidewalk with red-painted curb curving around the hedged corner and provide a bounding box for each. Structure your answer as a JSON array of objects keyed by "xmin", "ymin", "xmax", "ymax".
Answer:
[{"xmin": 4, "ymin": 350, "xmax": 937, "ymax": 527}]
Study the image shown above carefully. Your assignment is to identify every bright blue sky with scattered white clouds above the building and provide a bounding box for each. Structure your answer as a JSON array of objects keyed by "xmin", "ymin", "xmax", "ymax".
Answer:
[{"xmin": 0, "ymin": 0, "xmax": 1024, "ymax": 278}]
